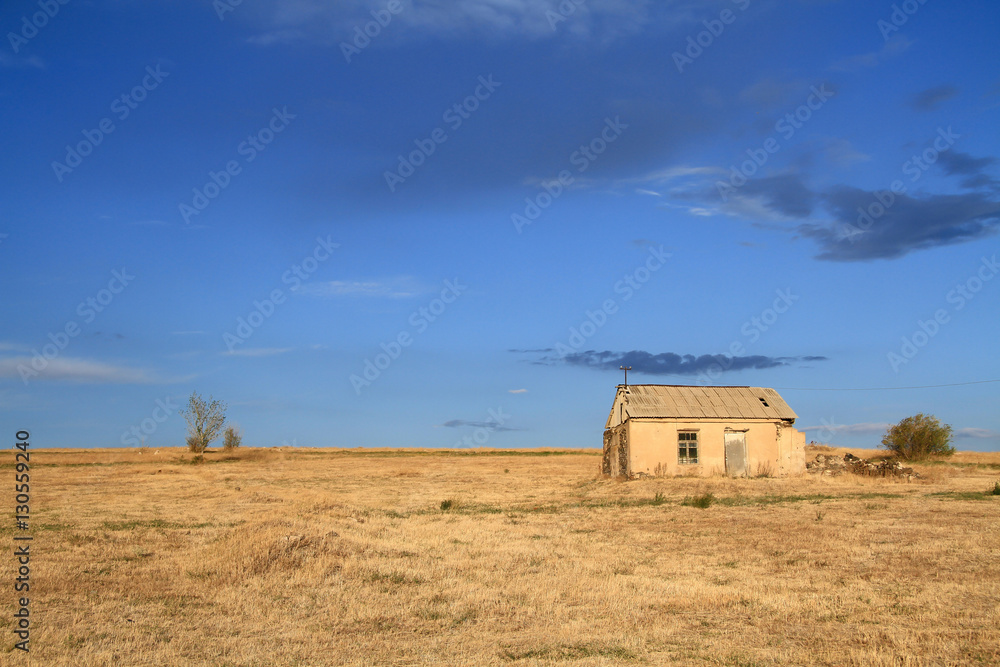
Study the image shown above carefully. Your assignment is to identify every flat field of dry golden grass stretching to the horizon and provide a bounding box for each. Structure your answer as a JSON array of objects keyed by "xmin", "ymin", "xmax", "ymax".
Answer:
[{"xmin": 0, "ymin": 449, "xmax": 1000, "ymax": 666}]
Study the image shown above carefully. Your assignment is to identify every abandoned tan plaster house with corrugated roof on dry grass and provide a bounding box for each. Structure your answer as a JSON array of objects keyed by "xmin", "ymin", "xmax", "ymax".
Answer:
[{"xmin": 602, "ymin": 384, "xmax": 805, "ymax": 477}]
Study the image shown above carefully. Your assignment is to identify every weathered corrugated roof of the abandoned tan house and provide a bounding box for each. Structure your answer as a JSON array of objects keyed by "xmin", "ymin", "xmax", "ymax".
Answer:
[{"xmin": 612, "ymin": 384, "xmax": 798, "ymax": 419}]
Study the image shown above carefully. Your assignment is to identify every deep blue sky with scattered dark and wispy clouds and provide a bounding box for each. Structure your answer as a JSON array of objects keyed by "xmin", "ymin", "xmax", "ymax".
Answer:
[{"xmin": 0, "ymin": 0, "xmax": 1000, "ymax": 450}]
